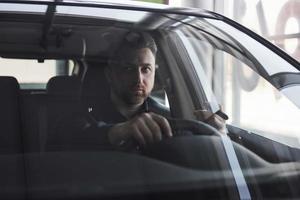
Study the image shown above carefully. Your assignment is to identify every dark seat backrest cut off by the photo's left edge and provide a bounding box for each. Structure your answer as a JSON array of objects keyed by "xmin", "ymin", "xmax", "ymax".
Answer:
[{"xmin": 0, "ymin": 76, "xmax": 23, "ymax": 154}]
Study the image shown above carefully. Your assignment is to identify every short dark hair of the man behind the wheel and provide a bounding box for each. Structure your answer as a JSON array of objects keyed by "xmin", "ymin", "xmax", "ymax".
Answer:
[{"xmin": 110, "ymin": 31, "xmax": 157, "ymax": 63}]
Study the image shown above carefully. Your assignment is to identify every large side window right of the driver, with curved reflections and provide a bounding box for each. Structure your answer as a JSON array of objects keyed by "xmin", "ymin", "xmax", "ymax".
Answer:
[{"xmin": 169, "ymin": 16, "xmax": 300, "ymax": 148}]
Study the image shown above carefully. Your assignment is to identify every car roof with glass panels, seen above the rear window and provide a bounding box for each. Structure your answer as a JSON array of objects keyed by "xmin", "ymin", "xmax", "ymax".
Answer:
[{"xmin": 0, "ymin": 0, "xmax": 223, "ymax": 59}]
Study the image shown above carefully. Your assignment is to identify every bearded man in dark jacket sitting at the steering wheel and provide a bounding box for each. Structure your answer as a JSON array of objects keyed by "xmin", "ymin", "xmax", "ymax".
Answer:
[{"xmin": 48, "ymin": 32, "xmax": 224, "ymax": 150}]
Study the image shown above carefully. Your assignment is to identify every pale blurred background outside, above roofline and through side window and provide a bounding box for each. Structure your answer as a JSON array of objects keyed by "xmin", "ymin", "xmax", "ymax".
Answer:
[{"xmin": 141, "ymin": 0, "xmax": 300, "ymax": 147}]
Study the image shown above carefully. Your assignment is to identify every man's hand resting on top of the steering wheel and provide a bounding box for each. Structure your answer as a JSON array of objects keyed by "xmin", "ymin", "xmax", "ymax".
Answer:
[{"xmin": 108, "ymin": 113, "xmax": 173, "ymax": 146}]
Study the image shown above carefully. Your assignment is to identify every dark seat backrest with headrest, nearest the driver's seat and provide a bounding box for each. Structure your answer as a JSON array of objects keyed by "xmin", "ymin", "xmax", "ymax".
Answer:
[{"xmin": 45, "ymin": 76, "xmax": 81, "ymax": 150}]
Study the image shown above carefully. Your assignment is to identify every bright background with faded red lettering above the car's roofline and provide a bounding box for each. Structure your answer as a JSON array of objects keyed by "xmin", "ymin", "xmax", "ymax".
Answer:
[{"xmin": 140, "ymin": 0, "xmax": 300, "ymax": 61}]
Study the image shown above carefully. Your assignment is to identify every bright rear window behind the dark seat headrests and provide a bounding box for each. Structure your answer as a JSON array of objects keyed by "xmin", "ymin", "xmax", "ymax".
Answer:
[{"xmin": 0, "ymin": 58, "xmax": 74, "ymax": 89}]
